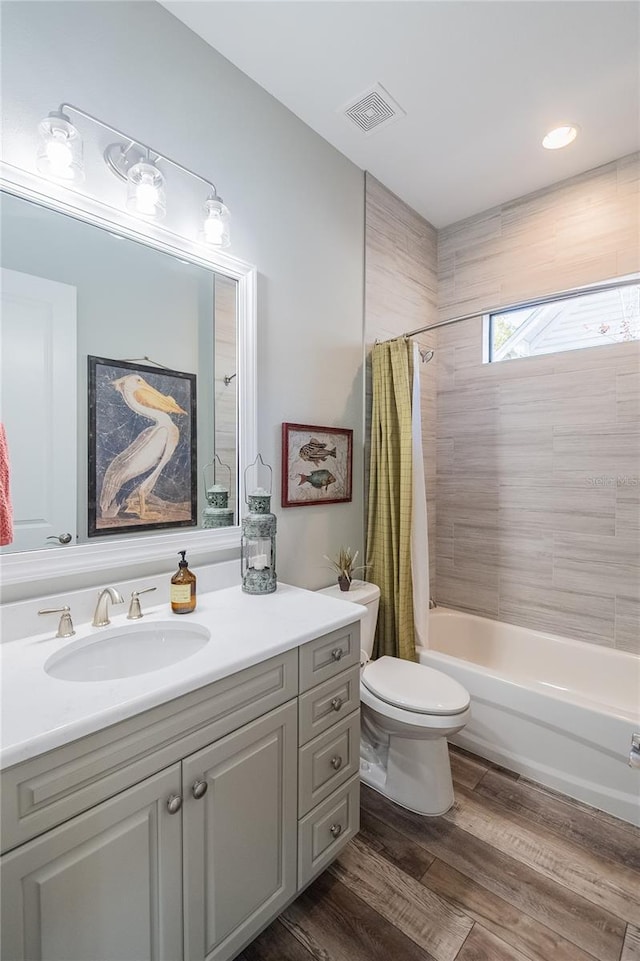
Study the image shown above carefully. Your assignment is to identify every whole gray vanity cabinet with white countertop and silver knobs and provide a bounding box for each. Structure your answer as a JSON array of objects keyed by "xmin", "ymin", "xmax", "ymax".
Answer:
[{"xmin": 0, "ymin": 587, "xmax": 360, "ymax": 961}]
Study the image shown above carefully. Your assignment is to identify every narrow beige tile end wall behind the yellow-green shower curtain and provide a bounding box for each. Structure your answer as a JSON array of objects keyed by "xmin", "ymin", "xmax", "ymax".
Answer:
[{"xmin": 364, "ymin": 174, "xmax": 437, "ymax": 583}]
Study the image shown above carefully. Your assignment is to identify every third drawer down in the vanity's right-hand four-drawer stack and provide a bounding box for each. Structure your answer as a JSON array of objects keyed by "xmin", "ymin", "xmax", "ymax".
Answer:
[{"xmin": 298, "ymin": 711, "xmax": 360, "ymax": 817}]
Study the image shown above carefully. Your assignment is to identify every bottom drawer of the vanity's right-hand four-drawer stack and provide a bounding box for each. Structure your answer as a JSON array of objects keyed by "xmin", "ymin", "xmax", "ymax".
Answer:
[{"xmin": 298, "ymin": 774, "xmax": 360, "ymax": 890}]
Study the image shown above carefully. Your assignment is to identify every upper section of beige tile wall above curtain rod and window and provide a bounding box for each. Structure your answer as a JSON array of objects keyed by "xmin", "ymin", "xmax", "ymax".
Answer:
[{"xmin": 438, "ymin": 154, "xmax": 640, "ymax": 320}]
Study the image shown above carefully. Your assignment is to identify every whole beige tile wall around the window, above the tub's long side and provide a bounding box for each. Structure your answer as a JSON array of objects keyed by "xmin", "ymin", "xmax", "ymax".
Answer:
[{"xmin": 435, "ymin": 155, "xmax": 640, "ymax": 652}]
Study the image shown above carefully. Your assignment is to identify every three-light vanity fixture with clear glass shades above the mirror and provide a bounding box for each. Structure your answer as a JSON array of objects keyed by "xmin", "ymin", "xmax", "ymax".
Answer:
[{"xmin": 36, "ymin": 103, "xmax": 231, "ymax": 240}]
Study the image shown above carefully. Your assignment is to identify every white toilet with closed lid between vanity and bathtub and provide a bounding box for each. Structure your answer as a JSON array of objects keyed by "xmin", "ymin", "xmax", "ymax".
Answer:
[{"xmin": 320, "ymin": 581, "xmax": 470, "ymax": 816}]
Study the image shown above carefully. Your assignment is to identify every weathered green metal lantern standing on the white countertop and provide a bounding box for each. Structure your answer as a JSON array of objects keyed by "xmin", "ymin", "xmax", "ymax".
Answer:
[{"xmin": 240, "ymin": 454, "xmax": 278, "ymax": 594}]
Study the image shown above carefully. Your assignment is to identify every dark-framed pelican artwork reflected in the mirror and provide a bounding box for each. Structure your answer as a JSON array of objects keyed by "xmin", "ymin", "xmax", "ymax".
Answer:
[{"xmin": 88, "ymin": 356, "xmax": 197, "ymax": 537}]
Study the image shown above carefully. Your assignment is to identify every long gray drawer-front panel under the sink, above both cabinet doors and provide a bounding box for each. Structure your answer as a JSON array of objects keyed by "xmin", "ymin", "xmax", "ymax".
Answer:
[{"xmin": 0, "ymin": 651, "xmax": 298, "ymax": 850}]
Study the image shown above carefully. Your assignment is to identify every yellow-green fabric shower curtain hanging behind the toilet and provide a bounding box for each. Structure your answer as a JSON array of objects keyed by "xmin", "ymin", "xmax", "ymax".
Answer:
[{"xmin": 367, "ymin": 338, "xmax": 428, "ymax": 660}]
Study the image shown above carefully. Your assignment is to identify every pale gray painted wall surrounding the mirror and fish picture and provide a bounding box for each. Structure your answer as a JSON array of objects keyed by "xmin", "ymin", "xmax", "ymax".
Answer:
[{"xmin": 2, "ymin": 0, "xmax": 364, "ymax": 587}]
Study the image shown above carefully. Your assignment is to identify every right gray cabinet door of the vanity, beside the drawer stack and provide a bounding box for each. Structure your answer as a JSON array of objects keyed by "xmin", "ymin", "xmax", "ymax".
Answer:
[{"xmin": 183, "ymin": 701, "xmax": 297, "ymax": 961}]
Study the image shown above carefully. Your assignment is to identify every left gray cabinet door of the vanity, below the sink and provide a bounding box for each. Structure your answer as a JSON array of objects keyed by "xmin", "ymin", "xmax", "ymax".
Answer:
[{"xmin": 0, "ymin": 764, "xmax": 182, "ymax": 961}]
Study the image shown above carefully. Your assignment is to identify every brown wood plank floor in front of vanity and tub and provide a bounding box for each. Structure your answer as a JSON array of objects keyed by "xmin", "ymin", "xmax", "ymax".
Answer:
[{"xmin": 238, "ymin": 748, "xmax": 640, "ymax": 961}]
